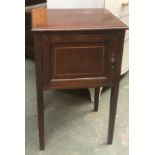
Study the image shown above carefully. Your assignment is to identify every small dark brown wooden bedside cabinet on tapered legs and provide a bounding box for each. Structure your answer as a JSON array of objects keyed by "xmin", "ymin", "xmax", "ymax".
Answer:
[{"xmin": 32, "ymin": 9, "xmax": 127, "ymax": 150}]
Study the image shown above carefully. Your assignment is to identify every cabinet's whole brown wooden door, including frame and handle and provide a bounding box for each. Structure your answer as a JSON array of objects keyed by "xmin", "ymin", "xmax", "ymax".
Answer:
[{"xmin": 43, "ymin": 35, "xmax": 117, "ymax": 88}]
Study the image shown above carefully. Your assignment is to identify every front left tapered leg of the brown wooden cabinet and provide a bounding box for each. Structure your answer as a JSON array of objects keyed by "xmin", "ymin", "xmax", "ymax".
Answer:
[{"xmin": 34, "ymin": 34, "xmax": 44, "ymax": 150}]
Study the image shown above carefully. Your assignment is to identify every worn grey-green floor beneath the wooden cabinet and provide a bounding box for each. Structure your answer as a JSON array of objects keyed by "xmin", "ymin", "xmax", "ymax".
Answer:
[{"xmin": 25, "ymin": 59, "xmax": 129, "ymax": 155}]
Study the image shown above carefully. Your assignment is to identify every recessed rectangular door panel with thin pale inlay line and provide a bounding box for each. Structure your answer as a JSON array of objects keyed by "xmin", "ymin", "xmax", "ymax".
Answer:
[{"xmin": 51, "ymin": 44, "xmax": 107, "ymax": 79}]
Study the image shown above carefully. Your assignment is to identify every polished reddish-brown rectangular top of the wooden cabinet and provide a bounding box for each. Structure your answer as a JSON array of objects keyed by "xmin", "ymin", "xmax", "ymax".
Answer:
[{"xmin": 32, "ymin": 8, "xmax": 128, "ymax": 31}]
